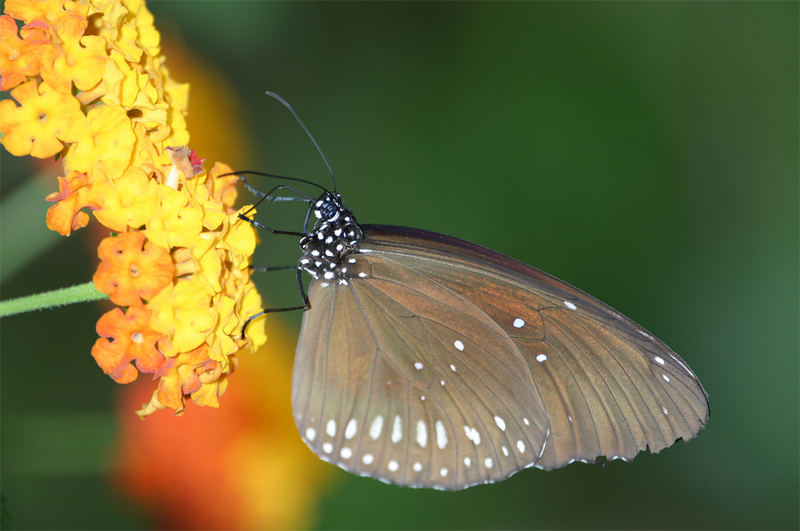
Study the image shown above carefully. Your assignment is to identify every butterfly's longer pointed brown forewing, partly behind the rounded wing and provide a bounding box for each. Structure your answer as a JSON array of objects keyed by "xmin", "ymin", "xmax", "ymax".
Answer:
[{"xmin": 362, "ymin": 226, "xmax": 709, "ymax": 469}]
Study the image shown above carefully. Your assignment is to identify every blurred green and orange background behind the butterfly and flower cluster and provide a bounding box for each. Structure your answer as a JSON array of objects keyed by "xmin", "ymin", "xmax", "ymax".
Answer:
[{"xmin": 0, "ymin": 1, "xmax": 800, "ymax": 529}]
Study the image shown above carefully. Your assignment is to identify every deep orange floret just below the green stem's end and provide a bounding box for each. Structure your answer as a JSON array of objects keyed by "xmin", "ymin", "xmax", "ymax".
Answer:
[{"xmin": 92, "ymin": 306, "xmax": 164, "ymax": 383}]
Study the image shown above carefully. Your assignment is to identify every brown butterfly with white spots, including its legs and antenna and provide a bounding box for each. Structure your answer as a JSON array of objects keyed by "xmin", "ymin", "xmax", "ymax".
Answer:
[{"xmin": 237, "ymin": 93, "xmax": 709, "ymax": 490}]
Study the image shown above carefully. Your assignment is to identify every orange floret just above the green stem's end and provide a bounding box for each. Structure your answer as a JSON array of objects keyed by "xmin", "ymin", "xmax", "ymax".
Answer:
[{"xmin": 93, "ymin": 232, "xmax": 175, "ymax": 306}]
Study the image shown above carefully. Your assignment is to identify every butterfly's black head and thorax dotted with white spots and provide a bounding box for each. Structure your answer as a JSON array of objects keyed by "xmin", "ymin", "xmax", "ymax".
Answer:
[{"xmin": 300, "ymin": 192, "xmax": 364, "ymax": 282}]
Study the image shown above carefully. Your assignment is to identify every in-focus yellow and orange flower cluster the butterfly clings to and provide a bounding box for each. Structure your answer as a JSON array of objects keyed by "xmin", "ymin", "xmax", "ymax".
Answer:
[{"xmin": 0, "ymin": 0, "xmax": 266, "ymax": 416}]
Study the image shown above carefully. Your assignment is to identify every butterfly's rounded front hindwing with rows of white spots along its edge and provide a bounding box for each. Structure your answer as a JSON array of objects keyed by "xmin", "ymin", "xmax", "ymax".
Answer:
[{"xmin": 293, "ymin": 255, "xmax": 547, "ymax": 489}]
